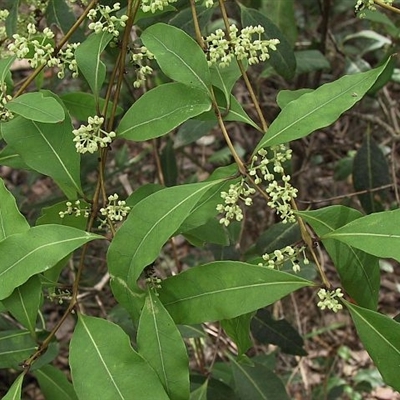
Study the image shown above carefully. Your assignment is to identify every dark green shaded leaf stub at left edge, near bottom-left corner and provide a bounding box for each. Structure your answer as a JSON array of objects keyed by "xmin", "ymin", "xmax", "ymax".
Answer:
[{"xmin": 0, "ymin": 329, "xmax": 37, "ymax": 370}]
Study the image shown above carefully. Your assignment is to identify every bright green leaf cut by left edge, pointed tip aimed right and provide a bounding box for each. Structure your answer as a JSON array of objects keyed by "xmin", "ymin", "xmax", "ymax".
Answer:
[{"xmin": 0, "ymin": 225, "xmax": 103, "ymax": 300}]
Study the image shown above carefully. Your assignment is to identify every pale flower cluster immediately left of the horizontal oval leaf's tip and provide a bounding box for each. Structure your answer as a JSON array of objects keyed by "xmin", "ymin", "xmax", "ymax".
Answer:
[{"xmin": 72, "ymin": 115, "xmax": 116, "ymax": 154}]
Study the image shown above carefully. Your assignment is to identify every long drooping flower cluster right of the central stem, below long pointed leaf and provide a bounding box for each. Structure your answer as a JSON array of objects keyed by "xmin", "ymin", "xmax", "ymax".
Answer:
[{"xmin": 249, "ymin": 144, "xmax": 297, "ymax": 223}]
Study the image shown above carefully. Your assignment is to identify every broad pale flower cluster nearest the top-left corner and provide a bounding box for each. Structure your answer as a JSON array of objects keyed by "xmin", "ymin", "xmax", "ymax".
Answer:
[{"xmin": 8, "ymin": 23, "xmax": 57, "ymax": 68}]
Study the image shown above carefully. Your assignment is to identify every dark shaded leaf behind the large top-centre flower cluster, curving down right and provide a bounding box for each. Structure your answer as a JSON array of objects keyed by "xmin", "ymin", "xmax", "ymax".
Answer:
[{"xmin": 239, "ymin": 4, "xmax": 296, "ymax": 79}]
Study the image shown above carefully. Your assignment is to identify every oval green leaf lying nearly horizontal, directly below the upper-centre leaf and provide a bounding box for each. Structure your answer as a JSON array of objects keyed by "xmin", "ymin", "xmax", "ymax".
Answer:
[{"xmin": 117, "ymin": 83, "xmax": 211, "ymax": 141}]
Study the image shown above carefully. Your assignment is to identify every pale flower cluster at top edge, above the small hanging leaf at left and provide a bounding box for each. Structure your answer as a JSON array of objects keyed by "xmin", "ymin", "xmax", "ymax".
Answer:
[{"xmin": 88, "ymin": 3, "xmax": 128, "ymax": 37}]
